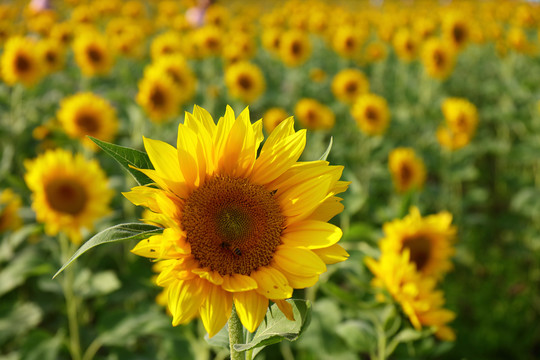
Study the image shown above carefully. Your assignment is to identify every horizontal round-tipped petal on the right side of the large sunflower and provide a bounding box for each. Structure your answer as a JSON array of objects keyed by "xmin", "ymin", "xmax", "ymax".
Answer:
[{"xmin": 282, "ymin": 220, "xmax": 343, "ymax": 249}]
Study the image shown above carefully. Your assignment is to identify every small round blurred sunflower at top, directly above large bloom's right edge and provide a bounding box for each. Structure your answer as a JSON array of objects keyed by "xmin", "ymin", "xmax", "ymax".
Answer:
[{"xmin": 279, "ymin": 30, "xmax": 311, "ymax": 66}]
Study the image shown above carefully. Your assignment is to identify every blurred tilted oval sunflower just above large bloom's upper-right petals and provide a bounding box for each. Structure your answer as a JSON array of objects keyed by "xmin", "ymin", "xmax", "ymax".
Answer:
[{"xmin": 294, "ymin": 98, "xmax": 336, "ymax": 130}]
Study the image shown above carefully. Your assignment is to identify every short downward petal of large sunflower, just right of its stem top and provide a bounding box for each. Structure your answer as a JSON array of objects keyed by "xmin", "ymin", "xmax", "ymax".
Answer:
[{"xmin": 233, "ymin": 290, "xmax": 268, "ymax": 333}]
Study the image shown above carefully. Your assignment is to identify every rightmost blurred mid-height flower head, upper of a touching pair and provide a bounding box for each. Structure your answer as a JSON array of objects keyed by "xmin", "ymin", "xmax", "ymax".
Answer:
[{"xmin": 442, "ymin": 98, "xmax": 478, "ymax": 138}]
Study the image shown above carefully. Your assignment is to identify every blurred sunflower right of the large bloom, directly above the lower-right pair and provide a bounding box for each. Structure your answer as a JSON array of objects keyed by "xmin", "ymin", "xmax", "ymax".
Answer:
[{"xmin": 388, "ymin": 148, "xmax": 426, "ymax": 193}]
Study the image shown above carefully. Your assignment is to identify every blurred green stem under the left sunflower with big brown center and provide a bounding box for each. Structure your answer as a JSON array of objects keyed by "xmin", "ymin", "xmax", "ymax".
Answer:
[{"xmin": 59, "ymin": 233, "xmax": 82, "ymax": 360}]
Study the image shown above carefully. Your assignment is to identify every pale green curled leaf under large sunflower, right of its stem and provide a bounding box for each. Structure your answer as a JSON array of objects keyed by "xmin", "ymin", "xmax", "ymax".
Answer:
[{"xmin": 234, "ymin": 299, "xmax": 311, "ymax": 355}]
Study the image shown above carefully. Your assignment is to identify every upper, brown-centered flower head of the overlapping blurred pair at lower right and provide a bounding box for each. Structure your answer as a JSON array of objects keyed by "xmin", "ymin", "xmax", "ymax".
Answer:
[{"xmin": 380, "ymin": 207, "xmax": 456, "ymax": 279}]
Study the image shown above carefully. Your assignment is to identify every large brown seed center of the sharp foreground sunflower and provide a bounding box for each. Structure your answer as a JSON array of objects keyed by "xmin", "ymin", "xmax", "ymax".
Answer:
[{"xmin": 181, "ymin": 176, "xmax": 285, "ymax": 275}]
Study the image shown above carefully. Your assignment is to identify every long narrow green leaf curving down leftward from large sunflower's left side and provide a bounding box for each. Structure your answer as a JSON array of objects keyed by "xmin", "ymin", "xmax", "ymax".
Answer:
[{"xmin": 53, "ymin": 223, "xmax": 163, "ymax": 279}]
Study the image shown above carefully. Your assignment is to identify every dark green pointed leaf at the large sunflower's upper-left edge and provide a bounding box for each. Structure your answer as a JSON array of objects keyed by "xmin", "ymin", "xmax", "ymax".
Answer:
[{"xmin": 89, "ymin": 136, "xmax": 154, "ymax": 185}]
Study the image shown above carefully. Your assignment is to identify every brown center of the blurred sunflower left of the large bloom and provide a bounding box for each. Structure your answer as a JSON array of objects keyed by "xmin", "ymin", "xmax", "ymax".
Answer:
[{"xmin": 45, "ymin": 178, "xmax": 88, "ymax": 215}]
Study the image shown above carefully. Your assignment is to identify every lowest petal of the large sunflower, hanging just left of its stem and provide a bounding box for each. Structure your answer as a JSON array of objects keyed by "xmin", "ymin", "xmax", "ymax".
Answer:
[{"xmin": 200, "ymin": 280, "xmax": 232, "ymax": 337}]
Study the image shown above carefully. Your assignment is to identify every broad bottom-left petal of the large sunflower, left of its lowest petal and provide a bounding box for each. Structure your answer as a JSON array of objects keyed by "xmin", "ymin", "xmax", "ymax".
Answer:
[{"xmin": 167, "ymin": 277, "xmax": 208, "ymax": 326}]
